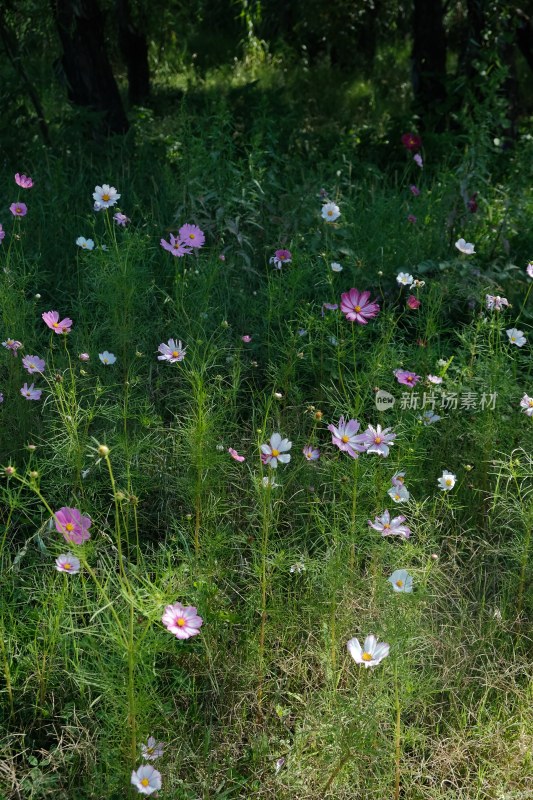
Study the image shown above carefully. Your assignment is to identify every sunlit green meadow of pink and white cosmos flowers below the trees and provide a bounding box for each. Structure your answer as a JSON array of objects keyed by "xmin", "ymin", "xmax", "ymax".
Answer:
[{"xmin": 0, "ymin": 4, "xmax": 533, "ymax": 800}]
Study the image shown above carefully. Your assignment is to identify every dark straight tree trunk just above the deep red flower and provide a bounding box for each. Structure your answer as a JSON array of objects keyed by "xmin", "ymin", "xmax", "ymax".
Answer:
[{"xmin": 412, "ymin": 0, "xmax": 446, "ymax": 122}]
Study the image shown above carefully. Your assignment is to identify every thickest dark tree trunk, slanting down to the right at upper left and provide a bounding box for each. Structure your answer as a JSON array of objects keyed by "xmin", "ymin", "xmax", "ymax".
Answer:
[{"xmin": 52, "ymin": 0, "xmax": 128, "ymax": 133}]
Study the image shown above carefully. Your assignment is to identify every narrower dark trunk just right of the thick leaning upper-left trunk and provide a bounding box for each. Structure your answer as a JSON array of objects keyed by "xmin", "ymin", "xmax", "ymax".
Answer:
[{"xmin": 116, "ymin": 0, "xmax": 150, "ymax": 106}]
